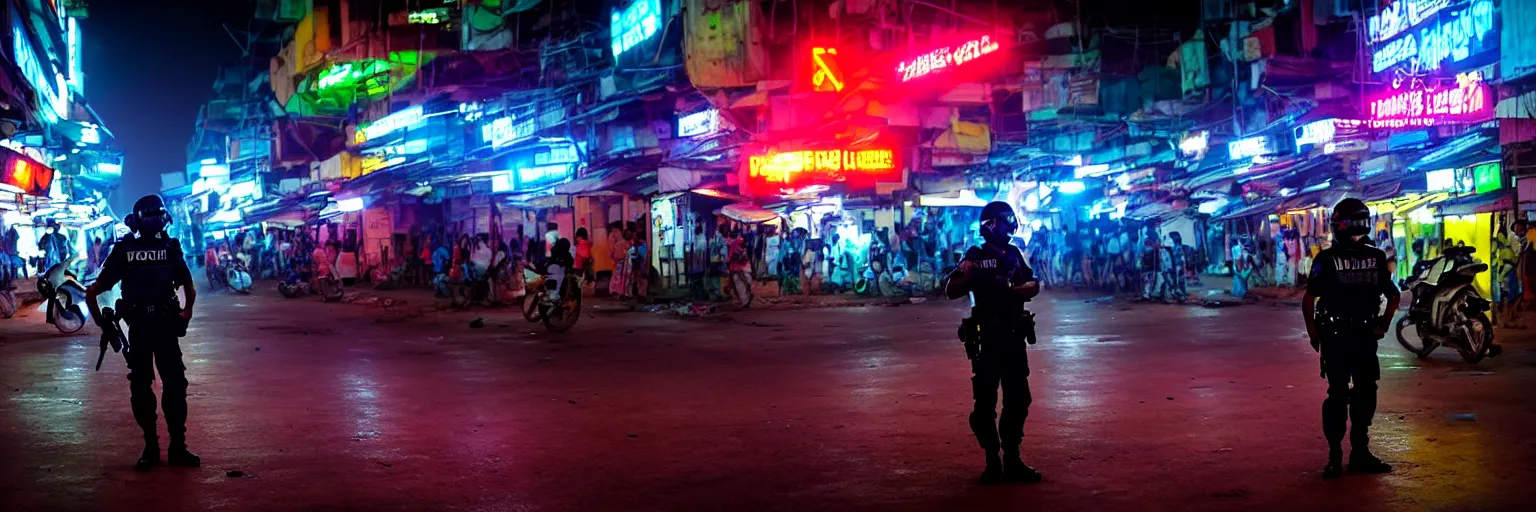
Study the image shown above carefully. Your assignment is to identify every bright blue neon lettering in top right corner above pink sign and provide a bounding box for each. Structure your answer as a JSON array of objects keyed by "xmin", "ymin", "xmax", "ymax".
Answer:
[{"xmin": 1370, "ymin": 0, "xmax": 1499, "ymax": 72}]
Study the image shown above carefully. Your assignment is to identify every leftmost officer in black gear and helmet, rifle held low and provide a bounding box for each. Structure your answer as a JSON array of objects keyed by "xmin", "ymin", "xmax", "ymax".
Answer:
[{"xmin": 86, "ymin": 195, "xmax": 201, "ymax": 469}]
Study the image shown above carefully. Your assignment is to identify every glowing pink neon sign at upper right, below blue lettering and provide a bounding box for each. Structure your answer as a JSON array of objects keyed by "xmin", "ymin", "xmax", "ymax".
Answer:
[{"xmin": 1367, "ymin": 72, "xmax": 1495, "ymax": 128}]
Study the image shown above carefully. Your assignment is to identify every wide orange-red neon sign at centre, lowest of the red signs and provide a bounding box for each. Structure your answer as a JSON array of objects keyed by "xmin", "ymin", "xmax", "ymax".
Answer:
[{"xmin": 742, "ymin": 148, "xmax": 902, "ymax": 195}]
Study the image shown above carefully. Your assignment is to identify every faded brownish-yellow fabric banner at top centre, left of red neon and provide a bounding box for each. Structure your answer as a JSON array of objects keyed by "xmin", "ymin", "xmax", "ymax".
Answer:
[{"xmin": 684, "ymin": 0, "xmax": 766, "ymax": 88}]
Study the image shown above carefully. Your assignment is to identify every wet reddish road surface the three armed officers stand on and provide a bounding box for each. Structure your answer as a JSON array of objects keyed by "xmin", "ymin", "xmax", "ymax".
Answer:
[{"xmin": 0, "ymin": 284, "xmax": 1536, "ymax": 510}]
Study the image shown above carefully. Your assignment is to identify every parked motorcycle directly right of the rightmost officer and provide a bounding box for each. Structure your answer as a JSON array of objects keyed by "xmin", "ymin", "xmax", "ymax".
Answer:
[{"xmin": 1396, "ymin": 248, "xmax": 1502, "ymax": 363}]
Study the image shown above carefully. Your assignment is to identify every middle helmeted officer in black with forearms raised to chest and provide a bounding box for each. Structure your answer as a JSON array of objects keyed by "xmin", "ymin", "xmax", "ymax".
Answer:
[{"xmin": 945, "ymin": 201, "xmax": 1041, "ymax": 484}]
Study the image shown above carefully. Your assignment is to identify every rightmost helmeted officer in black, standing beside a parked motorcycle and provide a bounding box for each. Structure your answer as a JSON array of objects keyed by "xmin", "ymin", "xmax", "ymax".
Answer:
[{"xmin": 1301, "ymin": 198, "xmax": 1399, "ymax": 478}]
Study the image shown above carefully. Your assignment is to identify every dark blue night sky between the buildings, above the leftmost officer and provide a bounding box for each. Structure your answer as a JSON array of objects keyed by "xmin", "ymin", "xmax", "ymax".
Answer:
[{"xmin": 81, "ymin": 0, "xmax": 250, "ymax": 214}]
